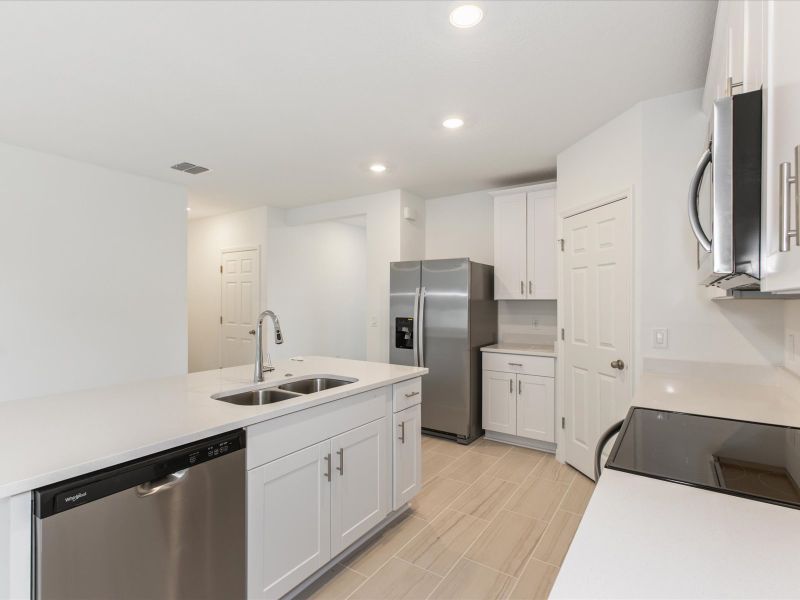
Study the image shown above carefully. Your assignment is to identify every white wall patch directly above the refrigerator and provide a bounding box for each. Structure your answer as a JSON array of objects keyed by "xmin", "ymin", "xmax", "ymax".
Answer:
[{"xmin": 425, "ymin": 190, "xmax": 494, "ymax": 265}]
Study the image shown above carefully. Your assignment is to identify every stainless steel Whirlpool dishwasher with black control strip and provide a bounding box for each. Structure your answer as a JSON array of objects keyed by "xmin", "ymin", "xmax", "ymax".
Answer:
[{"xmin": 33, "ymin": 429, "xmax": 246, "ymax": 600}]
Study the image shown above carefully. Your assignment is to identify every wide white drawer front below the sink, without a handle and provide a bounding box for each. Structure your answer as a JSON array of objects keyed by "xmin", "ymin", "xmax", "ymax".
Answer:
[{"xmin": 247, "ymin": 386, "xmax": 390, "ymax": 469}]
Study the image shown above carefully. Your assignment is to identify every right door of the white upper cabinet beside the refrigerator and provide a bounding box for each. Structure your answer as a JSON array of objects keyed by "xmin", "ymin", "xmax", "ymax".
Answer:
[{"xmin": 525, "ymin": 190, "xmax": 556, "ymax": 300}]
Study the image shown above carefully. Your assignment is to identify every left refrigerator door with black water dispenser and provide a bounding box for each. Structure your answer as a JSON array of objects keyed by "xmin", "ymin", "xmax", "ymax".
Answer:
[{"xmin": 389, "ymin": 260, "xmax": 420, "ymax": 366}]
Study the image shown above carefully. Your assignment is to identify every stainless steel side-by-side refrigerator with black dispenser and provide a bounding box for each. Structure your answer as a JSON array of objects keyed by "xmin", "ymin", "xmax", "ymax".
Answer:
[{"xmin": 389, "ymin": 258, "xmax": 497, "ymax": 444}]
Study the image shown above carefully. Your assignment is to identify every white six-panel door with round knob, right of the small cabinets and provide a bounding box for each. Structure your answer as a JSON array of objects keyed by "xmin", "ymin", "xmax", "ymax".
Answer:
[{"xmin": 563, "ymin": 198, "xmax": 633, "ymax": 478}]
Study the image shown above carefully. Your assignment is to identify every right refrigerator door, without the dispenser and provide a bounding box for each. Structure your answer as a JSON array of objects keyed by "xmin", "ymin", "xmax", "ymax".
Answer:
[{"xmin": 419, "ymin": 259, "xmax": 470, "ymax": 436}]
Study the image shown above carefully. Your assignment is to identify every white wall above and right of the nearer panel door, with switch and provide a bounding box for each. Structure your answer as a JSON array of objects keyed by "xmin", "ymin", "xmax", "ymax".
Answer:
[{"xmin": 557, "ymin": 90, "xmax": 783, "ymax": 376}]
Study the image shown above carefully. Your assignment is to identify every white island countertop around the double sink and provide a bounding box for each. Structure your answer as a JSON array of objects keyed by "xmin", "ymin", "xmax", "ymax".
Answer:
[{"xmin": 0, "ymin": 356, "xmax": 428, "ymax": 498}]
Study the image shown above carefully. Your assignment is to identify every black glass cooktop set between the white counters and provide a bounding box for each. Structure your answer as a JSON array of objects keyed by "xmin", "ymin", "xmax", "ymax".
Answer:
[{"xmin": 606, "ymin": 407, "xmax": 800, "ymax": 508}]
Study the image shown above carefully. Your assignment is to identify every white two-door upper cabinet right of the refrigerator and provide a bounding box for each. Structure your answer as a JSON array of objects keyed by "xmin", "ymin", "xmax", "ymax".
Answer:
[{"xmin": 494, "ymin": 183, "xmax": 556, "ymax": 300}]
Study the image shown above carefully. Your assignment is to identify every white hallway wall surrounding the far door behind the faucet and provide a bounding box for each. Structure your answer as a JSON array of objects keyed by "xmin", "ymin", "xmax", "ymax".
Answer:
[{"xmin": 187, "ymin": 206, "xmax": 267, "ymax": 372}]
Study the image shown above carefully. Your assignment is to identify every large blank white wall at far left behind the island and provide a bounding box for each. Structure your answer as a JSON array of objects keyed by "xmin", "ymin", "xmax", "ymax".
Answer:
[{"xmin": 0, "ymin": 144, "xmax": 186, "ymax": 400}]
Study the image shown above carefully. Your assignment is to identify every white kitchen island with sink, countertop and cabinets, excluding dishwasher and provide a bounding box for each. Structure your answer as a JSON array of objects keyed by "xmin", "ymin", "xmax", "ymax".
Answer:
[{"xmin": 0, "ymin": 357, "xmax": 427, "ymax": 598}]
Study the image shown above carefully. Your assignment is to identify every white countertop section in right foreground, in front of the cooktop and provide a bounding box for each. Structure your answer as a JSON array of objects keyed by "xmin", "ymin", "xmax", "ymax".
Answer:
[{"xmin": 550, "ymin": 469, "xmax": 800, "ymax": 599}]
